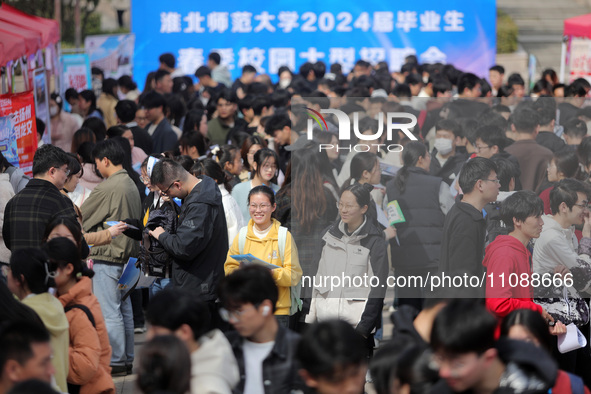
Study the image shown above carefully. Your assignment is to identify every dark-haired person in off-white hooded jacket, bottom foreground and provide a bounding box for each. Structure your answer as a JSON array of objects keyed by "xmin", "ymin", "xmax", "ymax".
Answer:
[{"xmin": 146, "ymin": 289, "xmax": 240, "ymax": 394}]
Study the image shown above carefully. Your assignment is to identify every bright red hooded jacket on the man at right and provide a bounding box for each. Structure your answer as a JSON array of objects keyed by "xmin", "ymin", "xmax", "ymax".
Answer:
[{"xmin": 482, "ymin": 235, "xmax": 542, "ymax": 318}]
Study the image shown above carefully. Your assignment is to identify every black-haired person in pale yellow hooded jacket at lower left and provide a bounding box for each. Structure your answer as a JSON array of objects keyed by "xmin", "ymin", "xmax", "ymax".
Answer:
[{"xmin": 4, "ymin": 248, "xmax": 69, "ymax": 393}]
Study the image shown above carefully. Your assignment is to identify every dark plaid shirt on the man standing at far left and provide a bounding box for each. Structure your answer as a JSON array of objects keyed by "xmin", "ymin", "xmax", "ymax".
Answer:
[{"xmin": 2, "ymin": 179, "xmax": 76, "ymax": 252}]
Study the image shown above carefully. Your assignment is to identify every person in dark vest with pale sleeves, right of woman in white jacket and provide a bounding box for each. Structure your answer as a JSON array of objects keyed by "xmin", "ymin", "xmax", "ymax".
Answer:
[{"xmin": 384, "ymin": 141, "xmax": 454, "ymax": 310}]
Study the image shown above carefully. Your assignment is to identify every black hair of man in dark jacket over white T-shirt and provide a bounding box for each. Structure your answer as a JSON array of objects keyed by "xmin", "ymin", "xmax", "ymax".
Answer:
[{"xmin": 218, "ymin": 265, "xmax": 279, "ymax": 312}]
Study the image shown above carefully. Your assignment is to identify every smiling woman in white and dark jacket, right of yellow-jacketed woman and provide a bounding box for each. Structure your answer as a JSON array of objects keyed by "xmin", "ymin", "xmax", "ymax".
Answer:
[{"xmin": 302, "ymin": 183, "xmax": 388, "ymax": 351}]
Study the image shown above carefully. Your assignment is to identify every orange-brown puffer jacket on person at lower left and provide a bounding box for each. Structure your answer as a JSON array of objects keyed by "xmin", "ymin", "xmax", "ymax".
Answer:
[{"xmin": 58, "ymin": 276, "xmax": 115, "ymax": 394}]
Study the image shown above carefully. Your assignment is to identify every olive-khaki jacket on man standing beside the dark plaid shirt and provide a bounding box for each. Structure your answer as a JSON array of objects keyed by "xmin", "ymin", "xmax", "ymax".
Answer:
[{"xmin": 80, "ymin": 170, "xmax": 142, "ymax": 264}]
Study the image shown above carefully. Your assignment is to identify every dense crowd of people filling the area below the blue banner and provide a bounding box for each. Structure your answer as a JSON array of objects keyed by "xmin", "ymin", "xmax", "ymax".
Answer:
[{"xmin": 0, "ymin": 52, "xmax": 591, "ymax": 394}]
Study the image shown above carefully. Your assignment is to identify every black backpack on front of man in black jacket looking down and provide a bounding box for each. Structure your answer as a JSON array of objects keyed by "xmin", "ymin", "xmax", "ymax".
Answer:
[{"xmin": 138, "ymin": 201, "xmax": 178, "ymax": 278}]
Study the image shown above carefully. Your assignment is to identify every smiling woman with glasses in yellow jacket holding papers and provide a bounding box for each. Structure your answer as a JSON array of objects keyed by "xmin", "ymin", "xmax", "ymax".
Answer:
[{"xmin": 224, "ymin": 186, "xmax": 302, "ymax": 327}]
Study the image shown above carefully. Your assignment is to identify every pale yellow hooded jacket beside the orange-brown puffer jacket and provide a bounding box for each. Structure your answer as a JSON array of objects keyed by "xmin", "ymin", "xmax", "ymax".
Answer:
[{"xmin": 23, "ymin": 293, "xmax": 69, "ymax": 393}]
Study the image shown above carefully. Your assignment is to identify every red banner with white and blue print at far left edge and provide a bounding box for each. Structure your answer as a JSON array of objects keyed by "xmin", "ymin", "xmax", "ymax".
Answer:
[{"xmin": 0, "ymin": 91, "xmax": 37, "ymax": 175}]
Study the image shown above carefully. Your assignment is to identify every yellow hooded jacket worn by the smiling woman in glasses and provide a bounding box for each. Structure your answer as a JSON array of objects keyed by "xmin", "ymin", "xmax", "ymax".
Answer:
[{"xmin": 224, "ymin": 219, "xmax": 302, "ymax": 315}]
